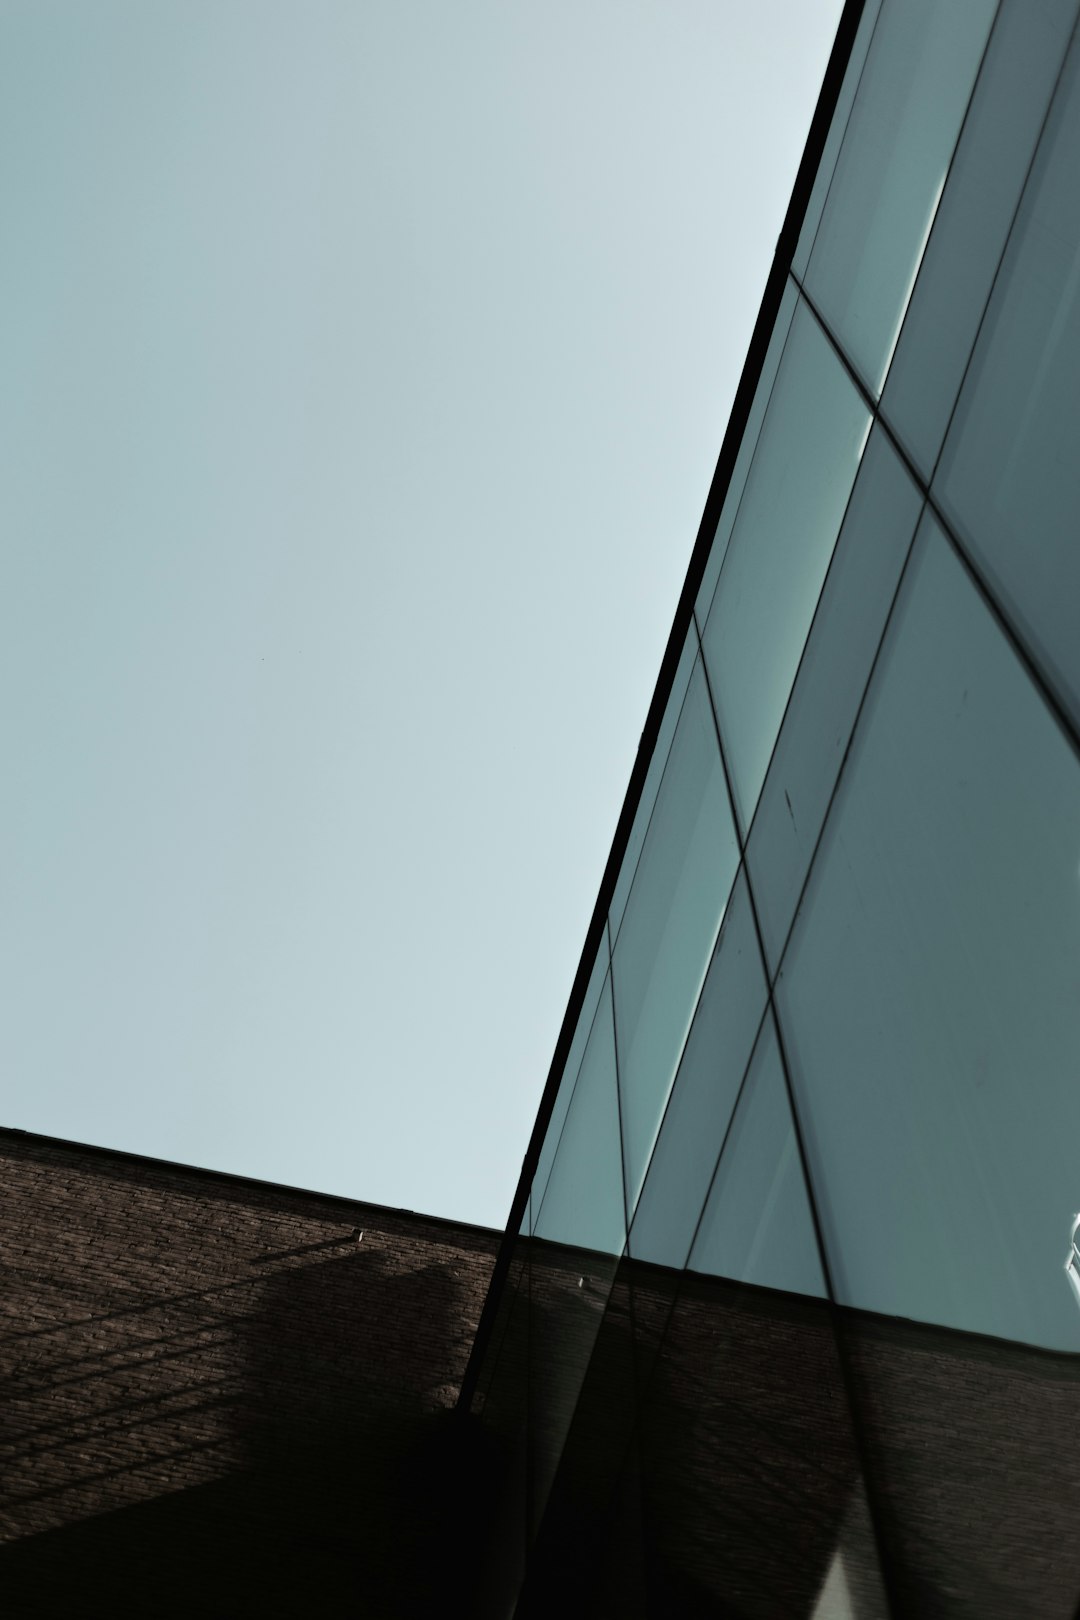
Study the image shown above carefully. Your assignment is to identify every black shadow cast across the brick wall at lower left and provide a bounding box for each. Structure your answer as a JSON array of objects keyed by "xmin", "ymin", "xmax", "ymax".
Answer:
[{"xmin": 0, "ymin": 1159, "xmax": 498, "ymax": 1620}]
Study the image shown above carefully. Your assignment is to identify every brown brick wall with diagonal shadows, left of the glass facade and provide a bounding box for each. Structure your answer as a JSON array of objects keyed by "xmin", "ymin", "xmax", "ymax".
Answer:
[{"xmin": 0, "ymin": 1132, "xmax": 499, "ymax": 1617}]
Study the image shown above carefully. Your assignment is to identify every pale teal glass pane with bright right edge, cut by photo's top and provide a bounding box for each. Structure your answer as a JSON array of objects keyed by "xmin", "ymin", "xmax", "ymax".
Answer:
[{"xmin": 805, "ymin": 0, "xmax": 996, "ymax": 394}]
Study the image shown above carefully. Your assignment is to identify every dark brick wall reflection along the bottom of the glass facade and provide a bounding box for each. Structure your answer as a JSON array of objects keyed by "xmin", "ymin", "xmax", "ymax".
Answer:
[{"xmin": 481, "ymin": 1244, "xmax": 1080, "ymax": 1620}]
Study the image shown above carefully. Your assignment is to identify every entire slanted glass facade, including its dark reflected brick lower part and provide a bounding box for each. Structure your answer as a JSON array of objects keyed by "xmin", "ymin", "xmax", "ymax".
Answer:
[{"xmin": 463, "ymin": 0, "xmax": 1080, "ymax": 1620}]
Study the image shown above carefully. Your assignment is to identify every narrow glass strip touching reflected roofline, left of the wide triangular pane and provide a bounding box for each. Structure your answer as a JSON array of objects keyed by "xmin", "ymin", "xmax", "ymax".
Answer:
[{"xmin": 630, "ymin": 875, "xmax": 766, "ymax": 1268}]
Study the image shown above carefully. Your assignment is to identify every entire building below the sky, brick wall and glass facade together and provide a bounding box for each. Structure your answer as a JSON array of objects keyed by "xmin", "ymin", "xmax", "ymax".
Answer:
[{"xmin": 0, "ymin": 0, "xmax": 1080, "ymax": 1620}]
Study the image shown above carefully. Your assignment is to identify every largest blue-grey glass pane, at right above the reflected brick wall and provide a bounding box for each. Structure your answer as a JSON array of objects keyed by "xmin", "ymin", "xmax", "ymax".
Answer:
[{"xmin": 777, "ymin": 518, "xmax": 1080, "ymax": 1351}]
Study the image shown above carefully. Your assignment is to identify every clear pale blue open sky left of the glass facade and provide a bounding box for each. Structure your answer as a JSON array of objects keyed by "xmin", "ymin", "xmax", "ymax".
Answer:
[{"xmin": 0, "ymin": 0, "xmax": 840, "ymax": 1226}]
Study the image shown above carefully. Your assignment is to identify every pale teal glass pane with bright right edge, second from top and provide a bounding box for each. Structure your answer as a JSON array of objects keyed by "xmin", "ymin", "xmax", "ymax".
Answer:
[{"xmin": 701, "ymin": 305, "xmax": 870, "ymax": 826}]
